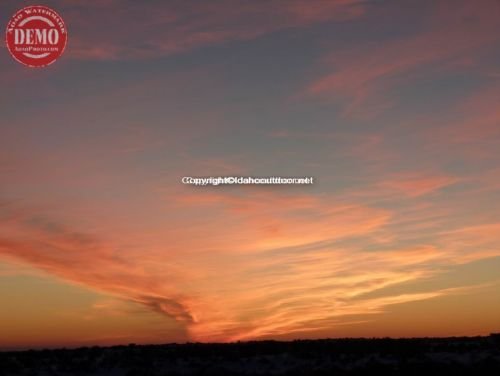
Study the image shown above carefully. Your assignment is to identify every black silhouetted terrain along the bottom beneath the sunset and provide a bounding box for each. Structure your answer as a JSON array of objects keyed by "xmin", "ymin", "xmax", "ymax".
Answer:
[{"xmin": 0, "ymin": 334, "xmax": 500, "ymax": 376}]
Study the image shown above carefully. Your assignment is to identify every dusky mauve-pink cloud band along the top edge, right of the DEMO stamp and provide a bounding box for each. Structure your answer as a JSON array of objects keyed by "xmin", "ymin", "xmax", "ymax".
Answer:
[{"xmin": 64, "ymin": 0, "xmax": 364, "ymax": 60}]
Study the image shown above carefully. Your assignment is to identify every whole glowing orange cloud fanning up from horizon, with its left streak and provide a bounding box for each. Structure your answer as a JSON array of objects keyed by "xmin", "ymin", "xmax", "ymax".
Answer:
[{"xmin": 0, "ymin": 189, "xmax": 495, "ymax": 341}]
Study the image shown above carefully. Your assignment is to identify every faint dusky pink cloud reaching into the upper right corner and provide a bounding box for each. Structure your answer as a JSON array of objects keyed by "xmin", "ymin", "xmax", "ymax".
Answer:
[{"xmin": 305, "ymin": 0, "xmax": 500, "ymax": 117}]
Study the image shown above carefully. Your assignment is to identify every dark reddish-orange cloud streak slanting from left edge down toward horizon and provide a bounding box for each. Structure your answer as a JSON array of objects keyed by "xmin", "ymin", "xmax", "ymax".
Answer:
[{"xmin": 0, "ymin": 204, "xmax": 194, "ymax": 322}]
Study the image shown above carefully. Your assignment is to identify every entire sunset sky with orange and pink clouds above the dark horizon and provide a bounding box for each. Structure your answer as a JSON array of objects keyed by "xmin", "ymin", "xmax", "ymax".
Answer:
[{"xmin": 0, "ymin": 0, "xmax": 500, "ymax": 349}]
